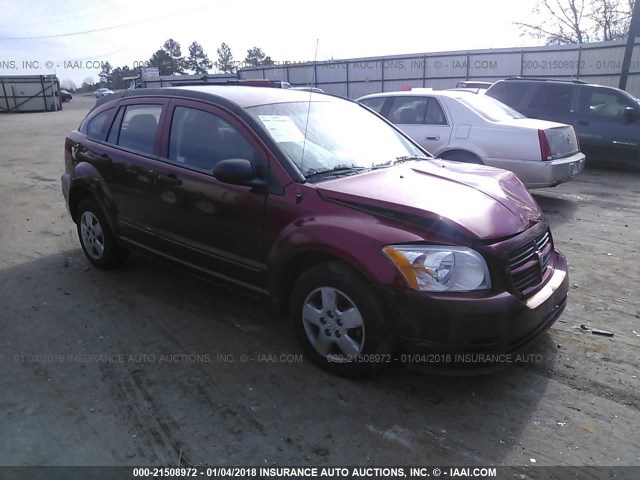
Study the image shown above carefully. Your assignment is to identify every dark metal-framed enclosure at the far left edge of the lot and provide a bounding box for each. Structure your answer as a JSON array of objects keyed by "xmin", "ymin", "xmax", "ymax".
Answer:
[{"xmin": 0, "ymin": 75, "xmax": 62, "ymax": 113}]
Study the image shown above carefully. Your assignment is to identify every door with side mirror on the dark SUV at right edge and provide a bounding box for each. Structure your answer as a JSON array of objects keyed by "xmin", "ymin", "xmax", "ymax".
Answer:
[{"xmin": 575, "ymin": 86, "xmax": 640, "ymax": 168}]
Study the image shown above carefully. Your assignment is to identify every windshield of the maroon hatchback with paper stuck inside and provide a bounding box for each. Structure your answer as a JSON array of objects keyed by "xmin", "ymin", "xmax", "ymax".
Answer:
[{"xmin": 247, "ymin": 101, "xmax": 430, "ymax": 177}]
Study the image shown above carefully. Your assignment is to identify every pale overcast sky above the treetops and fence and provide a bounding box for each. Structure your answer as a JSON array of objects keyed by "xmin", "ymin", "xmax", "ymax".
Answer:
[{"xmin": 0, "ymin": 0, "xmax": 540, "ymax": 86}]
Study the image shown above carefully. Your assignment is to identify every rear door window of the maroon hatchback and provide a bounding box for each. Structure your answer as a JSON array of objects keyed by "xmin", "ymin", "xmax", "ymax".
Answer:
[{"xmin": 118, "ymin": 105, "xmax": 162, "ymax": 154}]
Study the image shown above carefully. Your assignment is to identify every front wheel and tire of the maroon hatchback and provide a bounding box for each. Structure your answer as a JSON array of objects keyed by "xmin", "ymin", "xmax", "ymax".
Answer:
[{"xmin": 290, "ymin": 262, "xmax": 397, "ymax": 377}]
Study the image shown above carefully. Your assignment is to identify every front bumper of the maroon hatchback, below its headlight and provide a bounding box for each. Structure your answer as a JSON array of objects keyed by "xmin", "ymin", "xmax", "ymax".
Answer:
[{"xmin": 377, "ymin": 251, "xmax": 569, "ymax": 366}]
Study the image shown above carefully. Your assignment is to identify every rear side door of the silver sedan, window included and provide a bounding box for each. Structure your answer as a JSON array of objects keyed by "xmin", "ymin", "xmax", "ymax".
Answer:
[{"xmin": 386, "ymin": 95, "xmax": 452, "ymax": 153}]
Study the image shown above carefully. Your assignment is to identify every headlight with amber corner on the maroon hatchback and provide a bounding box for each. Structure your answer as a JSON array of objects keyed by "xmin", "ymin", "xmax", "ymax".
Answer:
[{"xmin": 382, "ymin": 245, "xmax": 491, "ymax": 292}]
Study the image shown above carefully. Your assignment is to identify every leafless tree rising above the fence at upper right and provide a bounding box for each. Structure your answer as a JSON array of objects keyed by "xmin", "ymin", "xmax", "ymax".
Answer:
[{"xmin": 515, "ymin": 0, "xmax": 634, "ymax": 45}]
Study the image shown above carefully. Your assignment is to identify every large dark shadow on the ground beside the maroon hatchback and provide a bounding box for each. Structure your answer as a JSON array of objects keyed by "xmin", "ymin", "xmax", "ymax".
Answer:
[{"xmin": 0, "ymin": 248, "xmax": 555, "ymax": 465}]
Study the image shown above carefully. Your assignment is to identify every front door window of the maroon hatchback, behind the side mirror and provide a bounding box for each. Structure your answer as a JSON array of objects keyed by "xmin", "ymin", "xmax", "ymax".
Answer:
[{"xmin": 169, "ymin": 107, "xmax": 257, "ymax": 172}]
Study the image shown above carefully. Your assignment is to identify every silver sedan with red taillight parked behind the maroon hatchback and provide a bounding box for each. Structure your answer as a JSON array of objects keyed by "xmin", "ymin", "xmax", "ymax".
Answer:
[{"xmin": 358, "ymin": 89, "xmax": 584, "ymax": 188}]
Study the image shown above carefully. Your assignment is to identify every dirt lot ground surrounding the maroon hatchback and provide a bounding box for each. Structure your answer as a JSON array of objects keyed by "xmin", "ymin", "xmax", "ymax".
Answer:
[{"xmin": 0, "ymin": 97, "xmax": 640, "ymax": 466}]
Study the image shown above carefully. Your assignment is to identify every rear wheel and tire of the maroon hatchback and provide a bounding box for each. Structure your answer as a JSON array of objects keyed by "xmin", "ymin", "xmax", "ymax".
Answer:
[{"xmin": 77, "ymin": 198, "xmax": 129, "ymax": 270}]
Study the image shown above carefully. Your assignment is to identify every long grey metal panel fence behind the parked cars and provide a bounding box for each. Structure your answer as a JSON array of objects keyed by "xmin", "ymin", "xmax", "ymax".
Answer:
[{"xmin": 238, "ymin": 38, "xmax": 640, "ymax": 98}]
